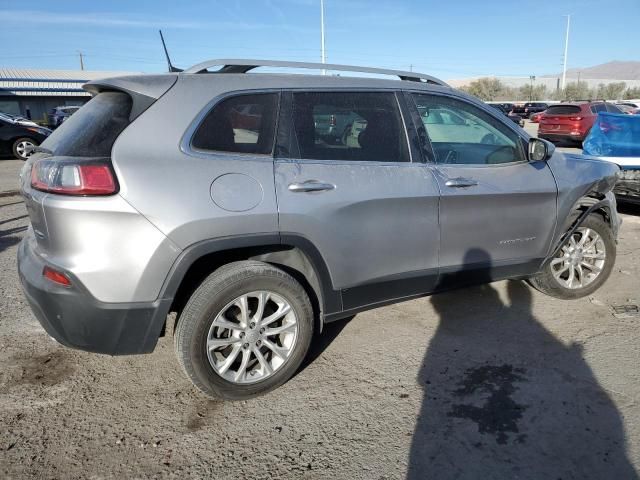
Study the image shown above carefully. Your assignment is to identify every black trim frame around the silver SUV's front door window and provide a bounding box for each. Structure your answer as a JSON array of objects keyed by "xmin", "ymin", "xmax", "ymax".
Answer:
[{"xmin": 406, "ymin": 89, "xmax": 531, "ymax": 168}]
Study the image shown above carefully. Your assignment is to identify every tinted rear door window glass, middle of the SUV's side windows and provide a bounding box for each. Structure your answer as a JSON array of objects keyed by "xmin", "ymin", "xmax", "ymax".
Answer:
[{"xmin": 293, "ymin": 92, "xmax": 409, "ymax": 162}]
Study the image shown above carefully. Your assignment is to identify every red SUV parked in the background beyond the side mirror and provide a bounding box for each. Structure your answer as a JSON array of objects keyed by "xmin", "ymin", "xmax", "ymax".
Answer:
[{"xmin": 538, "ymin": 101, "xmax": 622, "ymax": 143}]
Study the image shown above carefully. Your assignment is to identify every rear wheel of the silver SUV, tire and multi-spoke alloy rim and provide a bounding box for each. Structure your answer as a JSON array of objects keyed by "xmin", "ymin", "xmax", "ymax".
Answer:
[{"xmin": 175, "ymin": 261, "xmax": 313, "ymax": 400}]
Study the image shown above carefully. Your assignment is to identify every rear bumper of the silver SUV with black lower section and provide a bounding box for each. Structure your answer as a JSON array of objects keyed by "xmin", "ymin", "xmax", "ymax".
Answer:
[{"xmin": 18, "ymin": 236, "xmax": 170, "ymax": 355}]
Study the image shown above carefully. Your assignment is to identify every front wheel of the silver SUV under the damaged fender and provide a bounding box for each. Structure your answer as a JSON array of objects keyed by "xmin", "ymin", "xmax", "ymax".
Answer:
[{"xmin": 530, "ymin": 215, "xmax": 616, "ymax": 299}]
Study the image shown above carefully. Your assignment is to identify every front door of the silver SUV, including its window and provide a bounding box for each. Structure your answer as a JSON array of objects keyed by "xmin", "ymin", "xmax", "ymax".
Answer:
[{"xmin": 411, "ymin": 93, "xmax": 557, "ymax": 278}]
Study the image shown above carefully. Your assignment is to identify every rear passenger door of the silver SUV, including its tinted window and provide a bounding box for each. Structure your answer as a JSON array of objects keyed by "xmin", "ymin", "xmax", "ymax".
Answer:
[{"xmin": 275, "ymin": 91, "xmax": 439, "ymax": 310}]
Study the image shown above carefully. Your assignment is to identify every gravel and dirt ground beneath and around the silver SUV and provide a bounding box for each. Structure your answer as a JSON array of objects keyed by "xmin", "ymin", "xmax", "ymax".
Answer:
[{"xmin": 0, "ymin": 142, "xmax": 640, "ymax": 480}]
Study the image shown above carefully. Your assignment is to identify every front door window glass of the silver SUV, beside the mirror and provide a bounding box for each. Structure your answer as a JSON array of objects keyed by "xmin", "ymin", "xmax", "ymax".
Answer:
[{"xmin": 412, "ymin": 93, "xmax": 525, "ymax": 165}]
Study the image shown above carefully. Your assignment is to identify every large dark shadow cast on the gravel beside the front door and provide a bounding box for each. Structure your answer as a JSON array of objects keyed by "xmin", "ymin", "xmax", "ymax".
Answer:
[{"xmin": 407, "ymin": 250, "xmax": 638, "ymax": 480}]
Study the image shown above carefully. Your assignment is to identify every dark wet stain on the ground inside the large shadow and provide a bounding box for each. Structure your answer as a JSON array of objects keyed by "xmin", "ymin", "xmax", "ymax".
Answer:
[{"xmin": 447, "ymin": 365, "xmax": 527, "ymax": 445}]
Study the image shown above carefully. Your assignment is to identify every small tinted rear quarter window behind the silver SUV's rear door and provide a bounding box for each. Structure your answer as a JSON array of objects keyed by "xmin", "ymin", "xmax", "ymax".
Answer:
[{"xmin": 191, "ymin": 93, "xmax": 278, "ymax": 155}]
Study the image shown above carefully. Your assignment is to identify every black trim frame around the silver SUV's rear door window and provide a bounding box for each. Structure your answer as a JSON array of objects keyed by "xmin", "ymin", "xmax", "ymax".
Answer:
[{"xmin": 275, "ymin": 87, "xmax": 421, "ymax": 166}]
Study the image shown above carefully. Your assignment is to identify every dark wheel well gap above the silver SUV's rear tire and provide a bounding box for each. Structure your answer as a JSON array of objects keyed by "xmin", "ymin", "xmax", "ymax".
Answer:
[{"xmin": 168, "ymin": 244, "xmax": 323, "ymax": 335}]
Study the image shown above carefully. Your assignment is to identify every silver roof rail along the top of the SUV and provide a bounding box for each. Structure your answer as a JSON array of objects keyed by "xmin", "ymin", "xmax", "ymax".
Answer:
[{"xmin": 183, "ymin": 58, "xmax": 449, "ymax": 87}]
